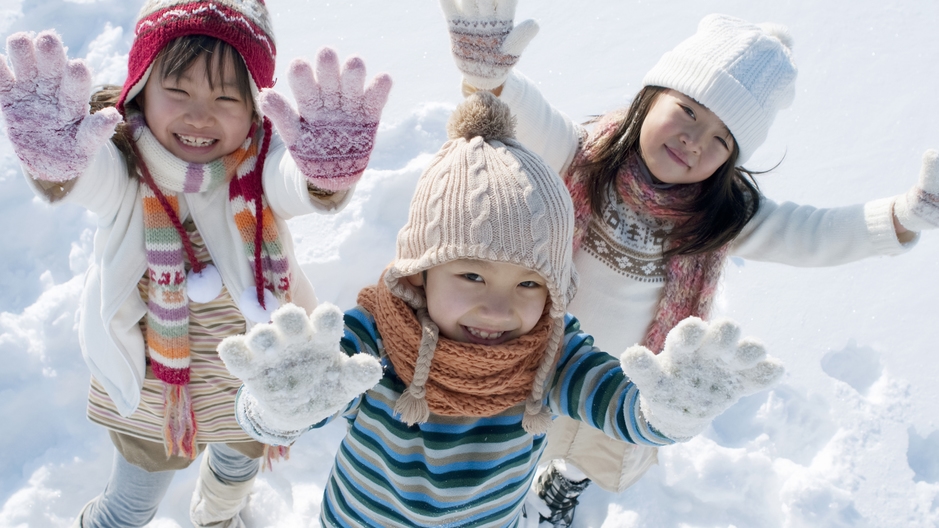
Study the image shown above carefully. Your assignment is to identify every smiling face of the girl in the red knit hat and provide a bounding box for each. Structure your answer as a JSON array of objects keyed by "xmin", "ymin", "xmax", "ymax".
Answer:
[{"xmin": 141, "ymin": 55, "xmax": 254, "ymax": 163}]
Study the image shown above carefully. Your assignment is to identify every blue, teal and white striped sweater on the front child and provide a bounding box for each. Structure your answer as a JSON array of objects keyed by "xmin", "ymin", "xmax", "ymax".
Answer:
[{"xmin": 242, "ymin": 308, "xmax": 672, "ymax": 528}]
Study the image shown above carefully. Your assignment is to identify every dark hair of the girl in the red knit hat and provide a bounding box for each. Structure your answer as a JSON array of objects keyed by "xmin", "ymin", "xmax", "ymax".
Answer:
[{"xmin": 91, "ymin": 35, "xmax": 256, "ymax": 169}]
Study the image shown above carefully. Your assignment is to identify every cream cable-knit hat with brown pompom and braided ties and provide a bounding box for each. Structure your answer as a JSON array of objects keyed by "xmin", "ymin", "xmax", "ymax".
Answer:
[{"xmin": 384, "ymin": 91, "xmax": 577, "ymax": 433}]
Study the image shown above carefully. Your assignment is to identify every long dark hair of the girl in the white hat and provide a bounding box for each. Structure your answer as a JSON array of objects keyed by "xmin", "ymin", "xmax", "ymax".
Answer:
[{"xmin": 577, "ymin": 86, "xmax": 760, "ymax": 257}]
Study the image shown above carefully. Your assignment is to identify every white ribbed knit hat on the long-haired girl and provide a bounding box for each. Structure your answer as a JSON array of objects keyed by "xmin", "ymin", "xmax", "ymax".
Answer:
[{"xmin": 642, "ymin": 14, "xmax": 797, "ymax": 165}]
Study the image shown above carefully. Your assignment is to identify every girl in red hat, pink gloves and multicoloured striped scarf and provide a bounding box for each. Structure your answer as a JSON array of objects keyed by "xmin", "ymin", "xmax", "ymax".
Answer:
[{"xmin": 0, "ymin": 0, "xmax": 391, "ymax": 528}]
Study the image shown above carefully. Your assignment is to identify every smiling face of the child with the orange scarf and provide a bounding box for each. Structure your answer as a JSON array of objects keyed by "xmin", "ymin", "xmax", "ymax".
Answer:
[{"xmin": 407, "ymin": 259, "xmax": 548, "ymax": 345}]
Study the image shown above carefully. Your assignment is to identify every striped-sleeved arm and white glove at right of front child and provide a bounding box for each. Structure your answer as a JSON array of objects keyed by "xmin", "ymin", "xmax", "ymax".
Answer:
[{"xmin": 549, "ymin": 317, "xmax": 783, "ymax": 446}]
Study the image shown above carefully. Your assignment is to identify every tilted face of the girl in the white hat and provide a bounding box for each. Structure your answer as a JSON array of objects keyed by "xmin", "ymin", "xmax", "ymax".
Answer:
[{"xmin": 639, "ymin": 90, "xmax": 734, "ymax": 183}]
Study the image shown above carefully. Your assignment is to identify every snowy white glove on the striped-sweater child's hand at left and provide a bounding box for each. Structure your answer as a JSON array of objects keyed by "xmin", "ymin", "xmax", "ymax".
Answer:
[{"xmin": 218, "ymin": 303, "xmax": 382, "ymax": 445}]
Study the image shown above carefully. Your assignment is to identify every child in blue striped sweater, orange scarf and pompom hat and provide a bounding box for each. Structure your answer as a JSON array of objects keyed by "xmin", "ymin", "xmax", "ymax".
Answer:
[{"xmin": 219, "ymin": 92, "xmax": 782, "ymax": 527}]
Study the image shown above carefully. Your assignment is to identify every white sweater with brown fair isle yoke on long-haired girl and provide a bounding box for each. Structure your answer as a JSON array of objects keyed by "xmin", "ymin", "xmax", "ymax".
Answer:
[{"xmin": 500, "ymin": 72, "xmax": 916, "ymax": 354}]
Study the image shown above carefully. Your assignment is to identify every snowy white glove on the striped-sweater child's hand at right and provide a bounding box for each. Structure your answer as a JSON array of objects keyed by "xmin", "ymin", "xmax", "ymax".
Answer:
[{"xmin": 620, "ymin": 317, "xmax": 785, "ymax": 442}]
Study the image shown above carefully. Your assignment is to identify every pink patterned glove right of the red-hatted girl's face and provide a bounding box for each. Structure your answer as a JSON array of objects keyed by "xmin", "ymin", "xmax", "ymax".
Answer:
[{"xmin": 258, "ymin": 48, "xmax": 391, "ymax": 191}]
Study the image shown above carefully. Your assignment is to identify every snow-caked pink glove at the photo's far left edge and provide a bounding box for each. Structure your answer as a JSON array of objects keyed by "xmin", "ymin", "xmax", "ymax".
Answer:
[{"xmin": 0, "ymin": 30, "xmax": 121, "ymax": 182}]
